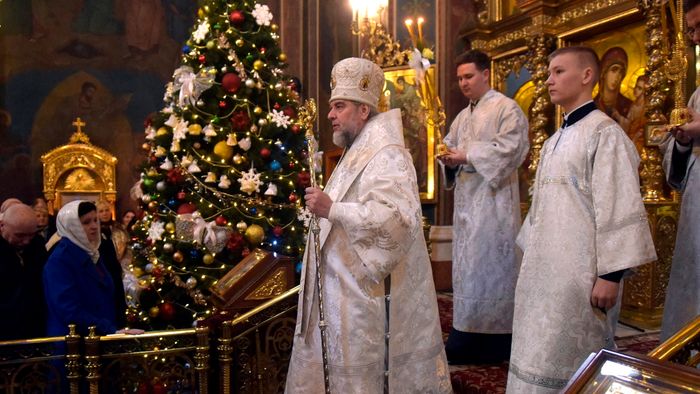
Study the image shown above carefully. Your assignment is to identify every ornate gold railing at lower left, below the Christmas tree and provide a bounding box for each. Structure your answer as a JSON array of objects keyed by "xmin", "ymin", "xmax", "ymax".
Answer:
[{"xmin": 0, "ymin": 286, "xmax": 299, "ymax": 394}]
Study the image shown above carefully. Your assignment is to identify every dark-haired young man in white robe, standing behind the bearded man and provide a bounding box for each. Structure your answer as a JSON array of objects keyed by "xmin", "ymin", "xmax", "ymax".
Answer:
[{"xmin": 439, "ymin": 50, "xmax": 529, "ymax": 364}]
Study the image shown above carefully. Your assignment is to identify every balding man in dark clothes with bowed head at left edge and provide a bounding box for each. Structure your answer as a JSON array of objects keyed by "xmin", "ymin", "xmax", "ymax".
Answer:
[{"xmin": 0, "ymin": 203, "xmax": 47, "ymax": 340}]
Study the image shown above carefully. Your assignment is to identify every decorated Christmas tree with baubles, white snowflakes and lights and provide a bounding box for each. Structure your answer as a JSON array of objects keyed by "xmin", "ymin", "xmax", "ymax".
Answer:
[{"xmin": 127, "ymin": 0, "xmax": 310, "ymax": 329}]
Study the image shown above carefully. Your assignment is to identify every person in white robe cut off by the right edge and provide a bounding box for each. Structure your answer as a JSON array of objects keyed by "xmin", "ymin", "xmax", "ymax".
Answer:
[{"xmin": 661, "ymin": 0, "xmax": 700, "ymax": 341}]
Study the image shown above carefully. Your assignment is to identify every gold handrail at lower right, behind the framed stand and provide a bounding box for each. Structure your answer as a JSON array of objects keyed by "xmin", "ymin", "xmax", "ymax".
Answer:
[{"xmin": 649, "ymin": 316, "xmax": 700, "ymax": 368}]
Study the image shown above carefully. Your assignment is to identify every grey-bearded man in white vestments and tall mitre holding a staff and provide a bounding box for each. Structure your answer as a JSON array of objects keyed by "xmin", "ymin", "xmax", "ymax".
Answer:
[{"xmin": 286, "ymin": 58, "xmax": 451, "ymax": 393}]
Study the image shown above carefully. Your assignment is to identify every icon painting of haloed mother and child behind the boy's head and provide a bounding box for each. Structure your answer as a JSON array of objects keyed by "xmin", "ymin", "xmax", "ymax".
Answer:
[{"xmin": 560, "ymin": 22, "xmax": 650, "ymax": 153}]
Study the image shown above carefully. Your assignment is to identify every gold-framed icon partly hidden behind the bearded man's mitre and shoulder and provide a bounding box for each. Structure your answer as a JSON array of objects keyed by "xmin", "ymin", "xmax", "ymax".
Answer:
[{"xmin": 379, "ymin": 65, "xmax": 437, "ymax": 203}]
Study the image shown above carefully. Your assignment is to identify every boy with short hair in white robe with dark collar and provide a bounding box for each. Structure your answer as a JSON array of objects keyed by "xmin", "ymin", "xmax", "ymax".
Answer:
[{"xmin": 506, "ymin": 47, "xmax": 656, "ymax": 394}]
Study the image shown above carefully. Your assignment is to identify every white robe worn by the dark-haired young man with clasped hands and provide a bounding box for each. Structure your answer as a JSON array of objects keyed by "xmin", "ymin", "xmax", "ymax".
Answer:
[{"xmin": 443, "ymin": 90, "xmax": 529, "ymax": 334}]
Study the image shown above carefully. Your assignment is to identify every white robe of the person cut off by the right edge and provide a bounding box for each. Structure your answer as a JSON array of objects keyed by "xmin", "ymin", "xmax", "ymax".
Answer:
[{"xmin": 661, "ymin": 88, "xmax": 700, "ymax": 341}]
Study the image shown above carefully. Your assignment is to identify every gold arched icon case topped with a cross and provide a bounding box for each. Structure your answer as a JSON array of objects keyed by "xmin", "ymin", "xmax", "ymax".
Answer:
[{"xmin": 41, "ymin": 131, "xmax": 117, "ymax": 218}]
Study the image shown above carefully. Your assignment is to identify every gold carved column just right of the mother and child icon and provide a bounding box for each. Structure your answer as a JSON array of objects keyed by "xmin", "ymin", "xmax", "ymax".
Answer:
[{"xmin": 620, "ymin": 0, "xmax": 679, "ymax": 329}]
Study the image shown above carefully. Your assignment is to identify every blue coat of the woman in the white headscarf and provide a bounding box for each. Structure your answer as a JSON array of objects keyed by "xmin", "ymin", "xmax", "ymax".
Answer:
[{"xmin": 44, "ymin": 238, "xmax": 117, "ymax": 336}]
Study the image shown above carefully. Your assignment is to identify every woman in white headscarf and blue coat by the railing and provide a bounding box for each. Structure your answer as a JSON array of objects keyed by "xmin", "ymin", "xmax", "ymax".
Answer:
[{"xmin": 44, "ymin": 201, "xmax": 140, "ymax": 336}]
